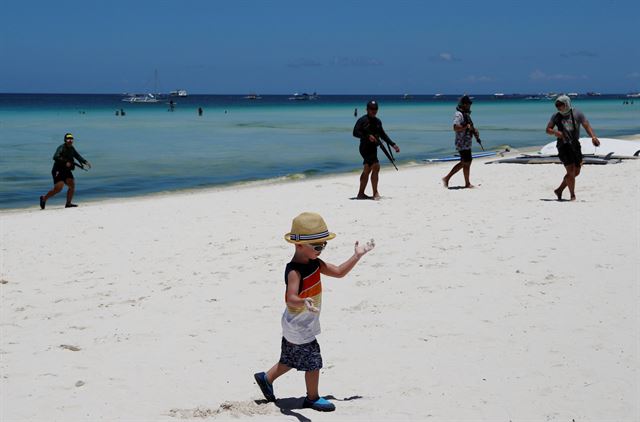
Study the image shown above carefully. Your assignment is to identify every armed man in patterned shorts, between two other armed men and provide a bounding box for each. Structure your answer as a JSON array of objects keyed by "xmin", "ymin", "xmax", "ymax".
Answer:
[{"xmin": 442, "ymin": 95, "xmax": 480, "ymax": 188}]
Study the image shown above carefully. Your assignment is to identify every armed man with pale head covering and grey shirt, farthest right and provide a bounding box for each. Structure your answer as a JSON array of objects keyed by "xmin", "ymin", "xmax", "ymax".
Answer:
[{"xmin": 546, "ymin": 95, "xmax": 600, "ymax": 201}]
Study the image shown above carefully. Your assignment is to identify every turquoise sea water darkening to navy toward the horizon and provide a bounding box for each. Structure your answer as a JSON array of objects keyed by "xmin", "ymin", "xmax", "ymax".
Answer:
[{"xmin": 0, "ymin": 94, "xmax": 640, "ymax": 209}]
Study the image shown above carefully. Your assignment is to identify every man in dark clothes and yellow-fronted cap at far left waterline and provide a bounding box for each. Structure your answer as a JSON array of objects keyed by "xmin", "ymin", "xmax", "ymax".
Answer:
[{"xmin": 40, "ymin": 133, "xmax": 91, "ymax": 209}]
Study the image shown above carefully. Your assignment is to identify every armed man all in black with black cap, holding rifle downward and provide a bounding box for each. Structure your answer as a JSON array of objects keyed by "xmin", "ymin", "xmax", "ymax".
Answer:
[{"xmin": 353, "ymin": 100, "xmax": 400, "ymax": 199}]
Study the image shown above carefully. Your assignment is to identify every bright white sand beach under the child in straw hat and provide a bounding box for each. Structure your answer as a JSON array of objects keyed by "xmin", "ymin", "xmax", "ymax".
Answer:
[{"xmin": 0, "ymin": 143, "xmax": 640, "ymax": 422}]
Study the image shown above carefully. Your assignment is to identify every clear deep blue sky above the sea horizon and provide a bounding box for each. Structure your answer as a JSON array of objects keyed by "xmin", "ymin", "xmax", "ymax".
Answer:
[{"xmin": 0, "ymin": 0, "xmax": 640, "ymax": 94}]
